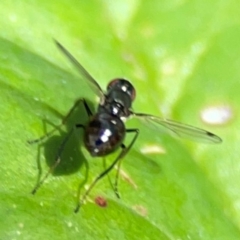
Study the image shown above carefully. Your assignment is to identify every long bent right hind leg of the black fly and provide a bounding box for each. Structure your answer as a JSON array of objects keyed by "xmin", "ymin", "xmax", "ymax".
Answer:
[{"xmin": 75, "ymin": 129, "xmax": 139, "ymax": 213}]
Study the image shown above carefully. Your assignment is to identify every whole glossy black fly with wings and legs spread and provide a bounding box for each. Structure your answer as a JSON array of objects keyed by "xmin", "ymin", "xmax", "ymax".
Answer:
[{"xmin": 29, "ymin": 41, "xmax": 222, "ymax": 212}]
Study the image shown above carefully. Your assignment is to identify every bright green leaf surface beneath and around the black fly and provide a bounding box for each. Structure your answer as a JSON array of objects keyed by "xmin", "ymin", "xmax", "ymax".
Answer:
[{"xmin": 0, "ymin": 0, "xmax": 240, "ymax": 240}]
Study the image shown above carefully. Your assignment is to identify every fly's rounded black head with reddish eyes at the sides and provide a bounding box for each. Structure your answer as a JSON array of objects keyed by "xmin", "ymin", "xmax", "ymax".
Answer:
[{"xmin": 107, "ymin": 78, "xmax": 136, "ymax": 101}]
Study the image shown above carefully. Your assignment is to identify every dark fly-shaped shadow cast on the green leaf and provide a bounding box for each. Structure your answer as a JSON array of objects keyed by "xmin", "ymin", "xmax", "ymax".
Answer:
[{"xmin": 29, "ymin": 98, "xmax": 93, "ymax": 189}]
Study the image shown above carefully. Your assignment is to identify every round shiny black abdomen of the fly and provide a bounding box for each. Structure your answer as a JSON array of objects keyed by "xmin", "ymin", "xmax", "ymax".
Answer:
[{"xmin": 84, "ymin": 112, "xmax": 126, "ymax": 156}]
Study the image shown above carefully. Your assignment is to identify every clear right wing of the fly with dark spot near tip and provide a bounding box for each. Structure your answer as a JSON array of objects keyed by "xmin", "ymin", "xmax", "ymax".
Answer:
[{"xmin": 132, "ymin": 113, "xmax": 222, "ymax": 143}]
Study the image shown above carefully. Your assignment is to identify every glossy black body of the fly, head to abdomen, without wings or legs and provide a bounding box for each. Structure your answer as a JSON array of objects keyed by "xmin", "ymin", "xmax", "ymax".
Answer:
[{"xmin": 84, "ymin": 79, "xmax": 135, "ymax": 156}]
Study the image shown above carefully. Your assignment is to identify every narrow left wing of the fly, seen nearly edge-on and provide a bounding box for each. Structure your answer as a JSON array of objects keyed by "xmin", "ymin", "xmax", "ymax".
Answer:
[{"xmin": 55, "ymin": 40, "xmax": 105, "ymax": 100}]
